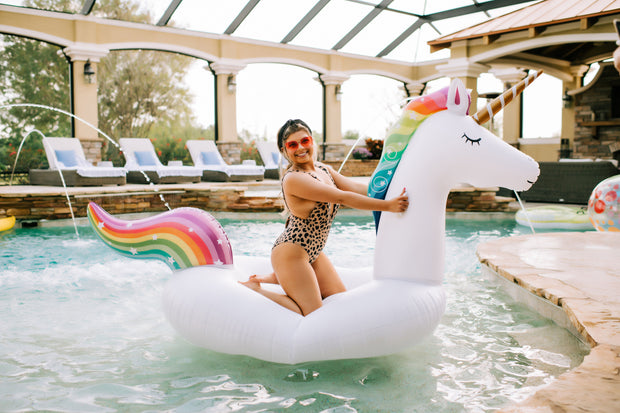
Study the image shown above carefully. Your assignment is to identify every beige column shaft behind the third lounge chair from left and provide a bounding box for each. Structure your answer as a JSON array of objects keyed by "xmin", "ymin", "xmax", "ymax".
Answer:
[{"xmin": 209, "ymin": 61, "xmax": 245, "ymax": 143}]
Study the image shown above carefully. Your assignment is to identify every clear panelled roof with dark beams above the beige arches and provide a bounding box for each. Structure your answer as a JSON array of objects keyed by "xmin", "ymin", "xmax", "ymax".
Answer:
[{"xmin": 0, "ymin": 0, "xmax": 535, "ymax": 62}]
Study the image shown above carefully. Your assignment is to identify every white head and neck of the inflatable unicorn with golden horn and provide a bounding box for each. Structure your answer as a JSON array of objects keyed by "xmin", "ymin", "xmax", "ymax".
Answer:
[{"xmin": 371, "ymin": 72, "xmax": 539, "ymax": 283}]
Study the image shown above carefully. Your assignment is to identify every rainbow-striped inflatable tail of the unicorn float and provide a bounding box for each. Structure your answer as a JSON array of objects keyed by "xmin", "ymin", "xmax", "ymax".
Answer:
[{"xmin": 88, "ymin": 202, "xmax": 233, "ymax": 270}]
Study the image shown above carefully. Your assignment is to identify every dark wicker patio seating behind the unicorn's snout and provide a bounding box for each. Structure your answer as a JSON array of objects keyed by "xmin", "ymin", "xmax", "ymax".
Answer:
[{"xmin": 521, "ymin": 159, "xmax": 620, "ymax": 204}]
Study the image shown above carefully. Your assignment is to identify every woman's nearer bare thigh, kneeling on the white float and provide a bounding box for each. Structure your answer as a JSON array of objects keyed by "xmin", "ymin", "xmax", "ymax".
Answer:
[{"xmin": 271, "ymin": 242, "xmax": 323, "ymax": 316}]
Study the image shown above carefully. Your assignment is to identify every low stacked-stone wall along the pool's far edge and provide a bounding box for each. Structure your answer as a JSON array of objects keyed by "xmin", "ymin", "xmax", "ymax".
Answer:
[{"xmin": 0, "ymin": 183, "xmax": 513, "ymax": 221}]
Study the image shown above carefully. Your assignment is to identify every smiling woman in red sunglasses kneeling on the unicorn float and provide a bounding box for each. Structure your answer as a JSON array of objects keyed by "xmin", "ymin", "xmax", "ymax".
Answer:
[{"xmin": 242, "ymin": 119, "xmax": 409, "ymax": 316}]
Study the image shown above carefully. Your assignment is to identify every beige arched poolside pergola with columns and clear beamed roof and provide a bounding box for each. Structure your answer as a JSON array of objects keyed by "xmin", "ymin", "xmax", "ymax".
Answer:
[{"xmin": 0, "ymin": 0, "xmax": 620, "ymax": 160}]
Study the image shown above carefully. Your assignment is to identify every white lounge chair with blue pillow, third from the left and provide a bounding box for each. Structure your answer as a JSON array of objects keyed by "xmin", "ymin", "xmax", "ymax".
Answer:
[{"xmin": 187, "ymin": 140, "xmax": 265, "ymax": 182}]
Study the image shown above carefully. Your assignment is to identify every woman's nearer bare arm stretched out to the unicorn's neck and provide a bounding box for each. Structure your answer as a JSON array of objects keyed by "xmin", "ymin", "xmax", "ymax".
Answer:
[{"xmin": 283, "ymin": 174, "xmax": 409, "ymax": 212}]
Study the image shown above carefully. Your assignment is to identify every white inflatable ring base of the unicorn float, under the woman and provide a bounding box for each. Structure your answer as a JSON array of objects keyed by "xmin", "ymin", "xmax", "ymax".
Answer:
[{"xmin": 164, "ymin": 257, "xmax": 445, "ymax": 364}]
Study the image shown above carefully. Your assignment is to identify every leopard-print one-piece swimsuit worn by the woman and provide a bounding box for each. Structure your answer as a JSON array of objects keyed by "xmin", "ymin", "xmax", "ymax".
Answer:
[{"xmin": 273, "ymin": 164, "xmax": 340, "ymax": 264}]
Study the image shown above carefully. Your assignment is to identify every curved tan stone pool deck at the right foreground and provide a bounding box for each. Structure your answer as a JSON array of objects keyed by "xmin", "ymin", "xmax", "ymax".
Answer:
[{"xmin": 477, "ymin": 232, "xmax": 620, "ymax": 413}]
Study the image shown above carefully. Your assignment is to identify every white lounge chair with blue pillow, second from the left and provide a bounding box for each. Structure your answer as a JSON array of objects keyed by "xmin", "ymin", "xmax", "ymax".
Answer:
[{"xmin": 118, "ymin": 138, "xmax": 202, "ymax": 184}]
